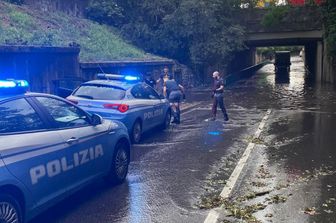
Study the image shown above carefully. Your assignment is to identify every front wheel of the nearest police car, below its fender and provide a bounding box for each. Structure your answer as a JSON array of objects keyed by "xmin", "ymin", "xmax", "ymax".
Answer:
[{"xmin": 105, "ymin": 141, "xmax": 130, "ymax": 185}]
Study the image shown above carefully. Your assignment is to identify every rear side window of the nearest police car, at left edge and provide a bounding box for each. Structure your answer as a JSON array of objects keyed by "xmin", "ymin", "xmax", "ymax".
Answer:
[{"xmin": 0, "ymin": 98, "xmax": 45, "ymax": 133}]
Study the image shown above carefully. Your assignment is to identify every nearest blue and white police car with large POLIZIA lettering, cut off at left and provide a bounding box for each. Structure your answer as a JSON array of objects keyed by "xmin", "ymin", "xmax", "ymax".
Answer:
[{"xmin": 0, "ymin": 80, "xmax": 130, "ymax": 223}]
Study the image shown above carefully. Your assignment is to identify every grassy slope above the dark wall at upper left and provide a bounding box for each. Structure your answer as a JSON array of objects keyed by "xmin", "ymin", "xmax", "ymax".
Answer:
[{"xmin": 0, "ymin": 1, "xmax": 162, "ymax": 61}]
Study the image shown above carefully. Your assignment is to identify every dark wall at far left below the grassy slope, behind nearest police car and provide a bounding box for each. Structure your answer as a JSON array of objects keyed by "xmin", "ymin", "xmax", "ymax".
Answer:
[{"xmin": 0, "ymin": 46, "xmax": 80, "ymax": 93}]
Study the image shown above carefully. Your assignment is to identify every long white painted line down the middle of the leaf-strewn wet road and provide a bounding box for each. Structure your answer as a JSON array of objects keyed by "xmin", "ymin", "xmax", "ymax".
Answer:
[{"xmin": 204, "ymin": 109, "xmax": 272, "ymax": 223}]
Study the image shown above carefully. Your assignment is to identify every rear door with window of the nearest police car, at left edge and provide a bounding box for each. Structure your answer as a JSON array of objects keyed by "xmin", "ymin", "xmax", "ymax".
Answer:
[{"xmin": 0, "ymin": 98, "xmax": 71, "ymax": 208}]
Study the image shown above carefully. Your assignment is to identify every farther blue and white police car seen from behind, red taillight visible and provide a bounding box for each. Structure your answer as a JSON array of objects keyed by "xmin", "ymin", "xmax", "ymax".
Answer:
[{"xmin": 67, "ymin": 74, "xmax": 171, "ymax": 143}]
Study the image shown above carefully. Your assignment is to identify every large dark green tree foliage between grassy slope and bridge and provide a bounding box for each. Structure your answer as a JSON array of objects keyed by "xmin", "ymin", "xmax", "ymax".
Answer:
[{"xmin": 88, "ymin": 0, "xmax": 244, "ymax": 75}]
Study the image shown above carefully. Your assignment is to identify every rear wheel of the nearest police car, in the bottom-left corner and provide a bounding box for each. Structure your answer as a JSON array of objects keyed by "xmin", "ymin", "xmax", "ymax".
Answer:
[{"xmin": 0, "ymin": 193, "xmax": 23, "ymax": 223}]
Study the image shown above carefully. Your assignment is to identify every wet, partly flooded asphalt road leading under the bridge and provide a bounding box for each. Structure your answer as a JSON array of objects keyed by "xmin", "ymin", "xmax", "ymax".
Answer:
[{"xmin": 32, "ymin": 57, "xmax": 336, "ymax": 223}]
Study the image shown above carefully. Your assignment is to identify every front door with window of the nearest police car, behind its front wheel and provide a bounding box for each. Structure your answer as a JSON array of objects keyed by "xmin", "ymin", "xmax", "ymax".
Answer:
[{"xmin": 36, "ymin": 97, "xmax": 113, "ymax": 179}]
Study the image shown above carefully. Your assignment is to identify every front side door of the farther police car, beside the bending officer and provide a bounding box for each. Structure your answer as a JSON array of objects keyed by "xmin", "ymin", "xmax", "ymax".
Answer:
[{"xmin": 144, "ymin": 85, "xmax": 165, "ymax": 126}]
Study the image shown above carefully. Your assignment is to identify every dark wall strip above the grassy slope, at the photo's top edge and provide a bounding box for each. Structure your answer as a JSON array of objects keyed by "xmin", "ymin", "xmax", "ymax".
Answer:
[{"xmin": 24, "ymin": 0, "xmax": 90, "ymax": 17}]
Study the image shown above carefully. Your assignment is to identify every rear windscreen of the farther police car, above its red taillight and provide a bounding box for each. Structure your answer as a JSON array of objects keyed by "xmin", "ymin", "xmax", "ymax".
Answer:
[{"xmin": 73, "ymin": 84, "xmax": 125, "ymax": 100}]
